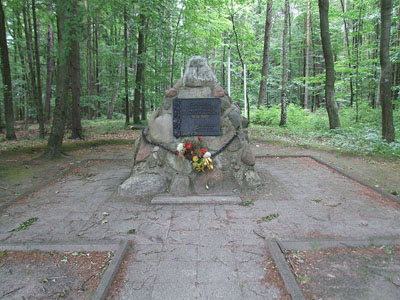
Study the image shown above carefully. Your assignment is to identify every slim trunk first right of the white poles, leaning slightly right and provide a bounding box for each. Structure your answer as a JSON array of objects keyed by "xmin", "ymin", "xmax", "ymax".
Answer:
[{"xmin": 257, "ymin": 0, "xmax": 273, "ymax": 108}]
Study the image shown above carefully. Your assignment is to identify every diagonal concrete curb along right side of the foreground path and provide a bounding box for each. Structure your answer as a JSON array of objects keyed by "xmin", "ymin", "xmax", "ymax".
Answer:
[{"xmin": 266, "ymin": 240, "xmax": 306, "ymax": 300}]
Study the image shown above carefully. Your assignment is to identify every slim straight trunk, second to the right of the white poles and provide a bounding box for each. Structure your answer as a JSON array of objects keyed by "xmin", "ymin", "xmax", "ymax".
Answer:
[{"xmin": 279, "ymin": 0, "xmax": 289, "ymax": 126}]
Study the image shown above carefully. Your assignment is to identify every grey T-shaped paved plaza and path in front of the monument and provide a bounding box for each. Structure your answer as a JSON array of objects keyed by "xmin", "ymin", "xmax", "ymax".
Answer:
[{"xmin": 0, "ymin": 151, "xmax": 400, "ymax": 300}]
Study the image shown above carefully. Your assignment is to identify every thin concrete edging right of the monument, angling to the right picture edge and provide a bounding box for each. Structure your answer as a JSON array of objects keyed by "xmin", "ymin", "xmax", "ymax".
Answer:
[{"xmin": 256, "ymin": 155, "xmax": 400, "ymax": 204}]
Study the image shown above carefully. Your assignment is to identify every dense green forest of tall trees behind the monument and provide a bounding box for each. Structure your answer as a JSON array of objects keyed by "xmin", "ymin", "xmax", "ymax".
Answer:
[{"xmin": 0, "ymin": 0, "xmax": 400, "ymax": 156}]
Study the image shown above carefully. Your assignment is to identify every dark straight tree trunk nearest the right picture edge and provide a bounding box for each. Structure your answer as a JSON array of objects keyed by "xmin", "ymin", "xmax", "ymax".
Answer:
[{"xmin": 379, "ymin": 0, "xmax": 395, "ymax": 143}]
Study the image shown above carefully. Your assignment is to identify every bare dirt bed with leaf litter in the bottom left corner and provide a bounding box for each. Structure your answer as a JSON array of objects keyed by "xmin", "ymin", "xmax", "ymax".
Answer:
[{"xmin": 0, "ymin": 251, "xmax": 113, "ymax": 300}]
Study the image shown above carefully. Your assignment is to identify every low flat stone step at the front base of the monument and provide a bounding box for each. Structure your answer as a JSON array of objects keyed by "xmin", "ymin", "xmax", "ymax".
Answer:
[{"xmin": 151, "ymin": 195, "xmax": 242, "ymax": 204}]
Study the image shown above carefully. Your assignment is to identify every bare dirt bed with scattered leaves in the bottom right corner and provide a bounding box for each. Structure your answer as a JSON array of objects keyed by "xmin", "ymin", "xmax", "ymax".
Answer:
[{"xmin": 286, "ymin": 246, "xmax": 400, "ymax": 300}]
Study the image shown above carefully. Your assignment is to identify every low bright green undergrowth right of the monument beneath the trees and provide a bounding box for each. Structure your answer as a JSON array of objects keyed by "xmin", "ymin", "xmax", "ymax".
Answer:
[{"xmin": 251, "ymin": 102, "xmax": 400, "ymax": 158}]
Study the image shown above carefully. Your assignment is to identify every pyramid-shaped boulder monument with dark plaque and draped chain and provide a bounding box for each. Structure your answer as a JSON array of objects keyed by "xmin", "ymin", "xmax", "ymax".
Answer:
[{"xmin": 118, "ymin": 56, "xmax": 262, "ymax": 202}]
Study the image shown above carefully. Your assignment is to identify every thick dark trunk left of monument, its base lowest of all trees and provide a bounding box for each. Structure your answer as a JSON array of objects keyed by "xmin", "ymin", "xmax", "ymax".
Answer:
[{"xmin": 44, "ymin": 0, "xmax": 72, "ymax": 158}]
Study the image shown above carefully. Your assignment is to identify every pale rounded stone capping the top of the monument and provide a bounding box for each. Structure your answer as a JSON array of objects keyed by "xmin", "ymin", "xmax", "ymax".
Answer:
[{"xmin": 183, "ymin": 56, "xmax": 217, "ymax": 87}]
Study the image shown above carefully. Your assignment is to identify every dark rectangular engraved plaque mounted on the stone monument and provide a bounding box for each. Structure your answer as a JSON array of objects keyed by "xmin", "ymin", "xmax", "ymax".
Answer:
[{"xmin": 173, "ymin": 98, "xmax": 221, "ymax": 138}]
